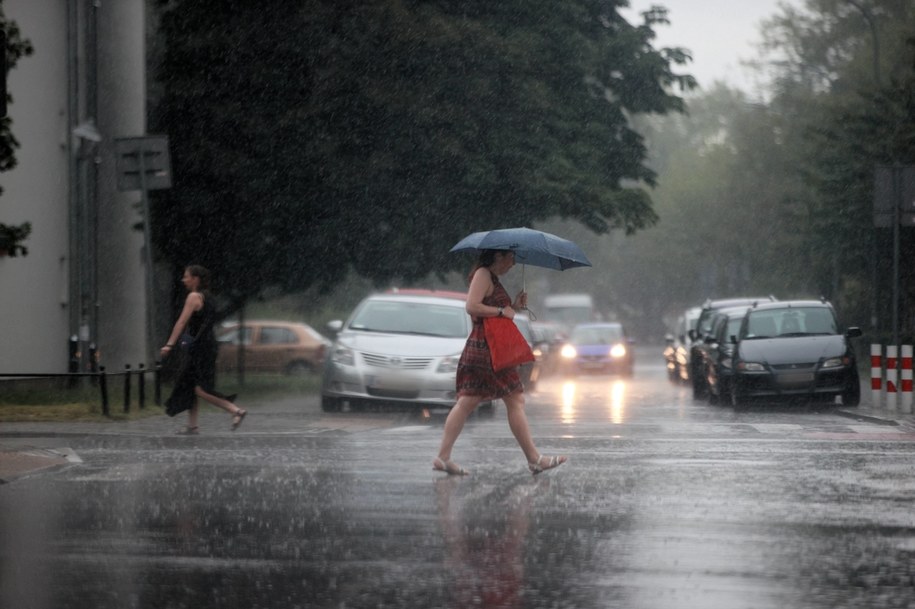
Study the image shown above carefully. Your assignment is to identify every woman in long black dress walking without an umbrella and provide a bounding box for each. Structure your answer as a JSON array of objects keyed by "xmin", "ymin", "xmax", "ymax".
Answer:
[{"xmin": 161, "ymin": 265, "xmax": 248, "ymax": 434}]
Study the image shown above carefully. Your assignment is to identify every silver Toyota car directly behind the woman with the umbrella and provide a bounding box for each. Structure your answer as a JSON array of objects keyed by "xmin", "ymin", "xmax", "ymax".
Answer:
[{"xmin": 321, "ymin": 289, "xmax": 471, "ymax": 412}]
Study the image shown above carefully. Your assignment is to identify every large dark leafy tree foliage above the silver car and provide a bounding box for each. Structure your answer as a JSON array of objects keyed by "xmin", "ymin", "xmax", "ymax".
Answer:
[{"xmin": 153, "ymin": 0, "xmax": 695, "ymax": 302}]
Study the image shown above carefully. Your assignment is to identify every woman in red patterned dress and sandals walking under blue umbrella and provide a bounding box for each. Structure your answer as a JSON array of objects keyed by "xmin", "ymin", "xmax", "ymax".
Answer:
[{"xmin": 432, "ymin": 249, "xmax": 567, "ymax": 475}]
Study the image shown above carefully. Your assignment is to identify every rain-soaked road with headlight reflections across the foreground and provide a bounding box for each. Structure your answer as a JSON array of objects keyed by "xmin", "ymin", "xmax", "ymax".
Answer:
[{"xmin": 0, "ymin": 350, "xmax": 915, "ymax": 609}]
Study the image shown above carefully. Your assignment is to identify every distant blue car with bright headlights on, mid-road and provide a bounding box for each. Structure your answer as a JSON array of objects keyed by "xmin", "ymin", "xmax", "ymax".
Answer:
[{"xmin": 560, "ymin": 322, "xmax": 635, "ymax": 377}]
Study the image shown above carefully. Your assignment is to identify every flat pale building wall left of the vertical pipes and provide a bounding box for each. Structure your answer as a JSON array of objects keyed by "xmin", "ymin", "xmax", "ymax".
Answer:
[{"xmin": 0, "ymin": 0, "xmax": 70, "ymax": 373}]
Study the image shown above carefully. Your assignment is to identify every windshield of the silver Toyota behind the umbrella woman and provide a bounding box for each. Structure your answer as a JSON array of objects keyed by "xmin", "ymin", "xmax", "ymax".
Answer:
[{"xmin": 349, "ymin": 300, "xmax": 470, "ymax": 338}]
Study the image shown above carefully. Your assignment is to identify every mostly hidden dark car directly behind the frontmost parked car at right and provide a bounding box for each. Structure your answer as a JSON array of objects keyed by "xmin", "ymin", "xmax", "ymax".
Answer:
[{"xmin": 698, "ymin": 306, "xmax": 749, "ymax": 404}]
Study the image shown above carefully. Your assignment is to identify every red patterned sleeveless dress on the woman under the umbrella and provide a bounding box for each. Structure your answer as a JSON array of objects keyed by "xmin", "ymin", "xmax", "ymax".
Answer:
[{"xmin": 457, "ymin": 273, "xmax": 523, "ymax": 400}]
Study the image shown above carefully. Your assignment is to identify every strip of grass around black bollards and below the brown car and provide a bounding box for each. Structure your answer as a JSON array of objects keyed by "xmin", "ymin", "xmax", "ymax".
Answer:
[{"xmin": 0, "ymin": 374, "xmax": 321, "ymax": 423}]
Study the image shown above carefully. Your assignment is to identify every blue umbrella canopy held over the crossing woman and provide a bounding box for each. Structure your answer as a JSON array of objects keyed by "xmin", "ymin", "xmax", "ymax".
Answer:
[{"xmin": 451, "ymin": 228, "xmax": 591, "ymax": 271}]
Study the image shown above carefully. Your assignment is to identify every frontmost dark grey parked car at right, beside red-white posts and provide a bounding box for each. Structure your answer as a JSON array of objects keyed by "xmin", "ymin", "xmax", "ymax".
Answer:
[{"xmin": 729, "ymin": 300, "xmax": 861, "ymax": 408}]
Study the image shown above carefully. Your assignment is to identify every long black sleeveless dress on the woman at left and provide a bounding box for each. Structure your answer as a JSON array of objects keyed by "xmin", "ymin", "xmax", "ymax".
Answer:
[{"xmin": 165, "ymin": 292, "xmax": 225, "ymax": 417}]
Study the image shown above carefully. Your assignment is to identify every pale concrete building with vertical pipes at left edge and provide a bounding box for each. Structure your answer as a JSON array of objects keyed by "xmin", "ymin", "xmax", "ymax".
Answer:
[{"xmin": 0, "ymin": 0, "xmax": 152, "ymax": 373}]
